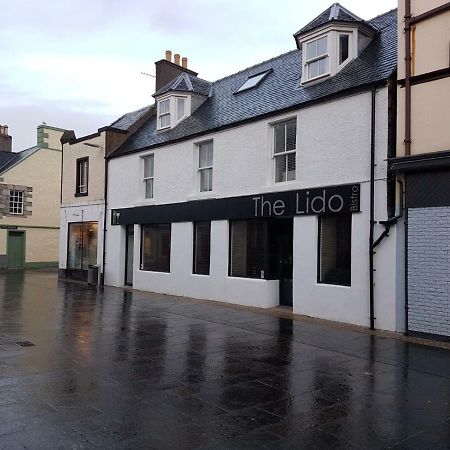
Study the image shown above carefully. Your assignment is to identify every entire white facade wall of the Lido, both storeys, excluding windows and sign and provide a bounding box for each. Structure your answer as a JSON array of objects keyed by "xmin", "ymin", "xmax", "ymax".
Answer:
[{"xmin": 106, "ymin": 88, "xmax": 402, "ymax": 330}]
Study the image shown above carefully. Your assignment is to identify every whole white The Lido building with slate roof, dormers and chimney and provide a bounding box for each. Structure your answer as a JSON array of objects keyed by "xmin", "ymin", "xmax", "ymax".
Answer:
[{"xmin": 103, "ymin": 3, "xmax": 404, "ymax": 331}]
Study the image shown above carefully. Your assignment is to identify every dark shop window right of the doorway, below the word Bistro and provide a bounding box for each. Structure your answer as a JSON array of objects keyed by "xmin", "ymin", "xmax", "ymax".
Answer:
[{"xmin": 318, "ymin": 214, "xmax": 352, "ymax": 286}]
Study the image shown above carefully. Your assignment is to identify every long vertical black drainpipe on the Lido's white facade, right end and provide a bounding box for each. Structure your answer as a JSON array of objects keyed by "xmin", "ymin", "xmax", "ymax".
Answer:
[{"xmin": 369, "ymin": 86, "xmax": 377, "ymax": 330}]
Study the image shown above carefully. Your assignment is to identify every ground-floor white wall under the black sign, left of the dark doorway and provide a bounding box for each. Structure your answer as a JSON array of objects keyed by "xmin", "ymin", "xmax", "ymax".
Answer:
[{"xmin": 106, "ymin": 221, "xmax": 278, "ymax": 308}]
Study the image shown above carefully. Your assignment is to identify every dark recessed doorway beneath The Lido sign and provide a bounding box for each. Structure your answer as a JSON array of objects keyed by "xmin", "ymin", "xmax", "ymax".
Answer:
[{"xmin": 269, "ymin": 218, "xmax": 294, "ymax": 307}]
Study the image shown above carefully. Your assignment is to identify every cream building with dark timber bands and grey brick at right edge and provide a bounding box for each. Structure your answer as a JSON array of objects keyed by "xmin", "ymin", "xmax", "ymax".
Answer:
[{"xmin": 390, "ymin": 0, "xmax": 450, "ymax": 339}]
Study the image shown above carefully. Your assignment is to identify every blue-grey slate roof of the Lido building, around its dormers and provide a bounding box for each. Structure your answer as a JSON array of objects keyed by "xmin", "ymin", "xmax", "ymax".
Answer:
[{"xmin": 111, "ymin": 10, "xmax": 397, "ymax": 157}]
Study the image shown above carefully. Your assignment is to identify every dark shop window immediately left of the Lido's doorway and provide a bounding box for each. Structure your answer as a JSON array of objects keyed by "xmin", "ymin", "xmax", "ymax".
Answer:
[{"xmin": 229, "ymin": 219, "xmax": 268, "ymax": 278}]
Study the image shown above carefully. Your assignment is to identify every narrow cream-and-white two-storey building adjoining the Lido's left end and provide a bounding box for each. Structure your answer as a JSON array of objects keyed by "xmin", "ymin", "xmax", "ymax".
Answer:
[{"xmin": 59, "ymin": 107, "xmax": 150, "ymax": 281}]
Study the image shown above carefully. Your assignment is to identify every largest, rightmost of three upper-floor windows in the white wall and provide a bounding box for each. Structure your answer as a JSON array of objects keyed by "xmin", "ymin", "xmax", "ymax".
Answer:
[{"xmin": 273, "ymin": 119, "xmax": 297, "ymax": 183}]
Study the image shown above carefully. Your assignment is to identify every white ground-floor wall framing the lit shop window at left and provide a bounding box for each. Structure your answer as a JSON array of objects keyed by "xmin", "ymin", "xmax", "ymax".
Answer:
[{"xmin": 59, "ymin": 203, "xmax": 104, "ymax": 270}]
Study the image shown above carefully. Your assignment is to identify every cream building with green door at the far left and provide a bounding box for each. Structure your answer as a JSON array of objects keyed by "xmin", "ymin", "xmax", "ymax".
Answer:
[{"xmin": 0, "ymin": 125, "xmax": 64, "ymax": 269}]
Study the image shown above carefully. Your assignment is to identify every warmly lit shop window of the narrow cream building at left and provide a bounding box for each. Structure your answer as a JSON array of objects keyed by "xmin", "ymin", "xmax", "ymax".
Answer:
[{"xmin": 67, "ymin": 222, "xmax": 98, "ymax": 270}]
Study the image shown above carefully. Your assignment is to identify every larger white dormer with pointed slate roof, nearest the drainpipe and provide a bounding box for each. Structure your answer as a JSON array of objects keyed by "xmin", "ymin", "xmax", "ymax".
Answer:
[{"xmin": 294, "ymin": 3, "xmax": 376, "ymax": 84}]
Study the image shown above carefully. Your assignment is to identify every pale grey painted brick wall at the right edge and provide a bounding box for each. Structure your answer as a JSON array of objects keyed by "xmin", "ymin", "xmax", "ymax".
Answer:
[{"xmin": 408, "ymin": 207, "xmax": 450, "ymax": 336}]
